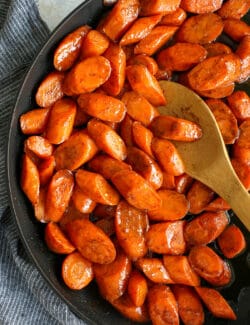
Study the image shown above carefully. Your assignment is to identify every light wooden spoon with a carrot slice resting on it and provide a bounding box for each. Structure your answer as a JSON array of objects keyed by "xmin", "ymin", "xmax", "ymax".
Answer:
[{"xmin": 159, "ymin": 81, "xmax": 250, "ymax": 231}]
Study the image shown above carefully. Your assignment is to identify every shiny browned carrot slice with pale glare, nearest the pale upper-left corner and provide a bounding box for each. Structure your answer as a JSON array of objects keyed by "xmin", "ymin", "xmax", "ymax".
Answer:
[{"xmin": 53, "ymin": 25, "xmax": 90, "ymax": 71}]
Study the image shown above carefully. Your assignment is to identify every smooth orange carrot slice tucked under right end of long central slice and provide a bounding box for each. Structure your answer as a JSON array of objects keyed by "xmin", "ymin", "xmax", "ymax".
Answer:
[{"xmin": 148, "ymin": 190, "xmax": 189, "ymax": 221}]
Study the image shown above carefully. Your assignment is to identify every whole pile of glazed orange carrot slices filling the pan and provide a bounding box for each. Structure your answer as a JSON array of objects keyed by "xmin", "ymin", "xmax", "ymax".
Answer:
[{"xmin": 20, "ymin": 0, "xmax": 250, "ymax": 325}]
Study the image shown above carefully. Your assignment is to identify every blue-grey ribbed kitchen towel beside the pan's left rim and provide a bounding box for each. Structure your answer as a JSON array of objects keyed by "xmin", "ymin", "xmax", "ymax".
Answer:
[{"xmin": 0, "ymin": 0, "xmax": 84, "ymax": 325}]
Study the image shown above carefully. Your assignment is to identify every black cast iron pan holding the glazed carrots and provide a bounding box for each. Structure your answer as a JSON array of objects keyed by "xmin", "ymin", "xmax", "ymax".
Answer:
[{"xmin": 7, "ymin": 0, "xmax": 250, "ymax": 325}]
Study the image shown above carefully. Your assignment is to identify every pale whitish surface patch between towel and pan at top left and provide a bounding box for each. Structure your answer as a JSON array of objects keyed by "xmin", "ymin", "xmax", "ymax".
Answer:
[{"xmin": 38, "ymin": 0, "xmax": 84, "ymax": 31}]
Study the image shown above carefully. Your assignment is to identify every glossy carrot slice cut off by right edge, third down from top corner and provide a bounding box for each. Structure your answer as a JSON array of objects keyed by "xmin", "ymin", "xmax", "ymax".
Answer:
[{"xmin": 235, "ymin": 35, "xmax": 250, "ymax": 82}]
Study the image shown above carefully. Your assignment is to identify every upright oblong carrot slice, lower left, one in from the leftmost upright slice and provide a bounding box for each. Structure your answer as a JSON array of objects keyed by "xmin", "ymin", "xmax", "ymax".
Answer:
[{"xmin": 45, "ymin": 169, "xmax": 74, "ymax": 222}]
